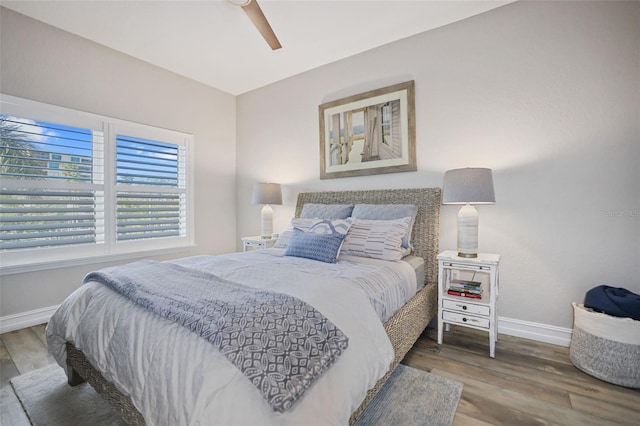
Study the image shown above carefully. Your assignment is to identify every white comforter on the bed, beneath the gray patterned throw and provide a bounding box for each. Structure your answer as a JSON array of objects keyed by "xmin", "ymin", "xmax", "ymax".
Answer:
[{"xmin": 46, "ymin": 250, "xmax": 416, "ymax": 425}]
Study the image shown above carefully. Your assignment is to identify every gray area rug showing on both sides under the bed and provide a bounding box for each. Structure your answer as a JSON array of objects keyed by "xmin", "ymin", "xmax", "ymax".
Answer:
[{"xmin": 11, "ymin": 364, "xmax": 462, "ymax": 426}]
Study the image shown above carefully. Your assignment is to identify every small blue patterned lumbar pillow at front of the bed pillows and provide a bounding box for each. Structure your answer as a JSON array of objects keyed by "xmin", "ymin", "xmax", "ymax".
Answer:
[{"xmin": 284, "ymin": 229, "xmax": 344, "ymax": 263}]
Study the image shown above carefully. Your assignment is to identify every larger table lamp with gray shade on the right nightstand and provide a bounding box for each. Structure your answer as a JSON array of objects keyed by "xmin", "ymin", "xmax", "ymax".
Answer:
[{"xmin": 442, "ymin": 167, "xmax": 496, "ymax": 257}]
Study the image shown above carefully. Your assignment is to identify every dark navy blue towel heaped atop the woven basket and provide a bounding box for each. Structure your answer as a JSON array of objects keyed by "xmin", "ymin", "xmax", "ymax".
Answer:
[{"xmin": 584, "ymin": 285, "xmax": 640, "ymax": 321}]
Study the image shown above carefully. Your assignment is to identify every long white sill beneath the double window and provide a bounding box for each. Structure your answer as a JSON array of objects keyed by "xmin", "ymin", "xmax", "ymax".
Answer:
[{"xmin": 0, "ymin": 245, "xmax": 196, "ymax": 276}]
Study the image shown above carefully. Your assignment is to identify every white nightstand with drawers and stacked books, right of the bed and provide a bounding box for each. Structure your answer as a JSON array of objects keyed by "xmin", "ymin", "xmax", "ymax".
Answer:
[{"xmin": 438, "ymin": 250, "xmax": 500, "ymax": 358}]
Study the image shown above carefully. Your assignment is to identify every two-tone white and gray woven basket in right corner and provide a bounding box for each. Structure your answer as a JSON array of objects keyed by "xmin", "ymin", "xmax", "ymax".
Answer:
[{"xmin": 569, "ymin": 303, "xmax": 640, "ymax": 388}]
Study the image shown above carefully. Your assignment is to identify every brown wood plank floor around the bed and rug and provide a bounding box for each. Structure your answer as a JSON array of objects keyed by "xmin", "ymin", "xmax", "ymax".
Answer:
[{"xmin": 0, "ymin": 325, "xmax": 640, "ymax": 426}]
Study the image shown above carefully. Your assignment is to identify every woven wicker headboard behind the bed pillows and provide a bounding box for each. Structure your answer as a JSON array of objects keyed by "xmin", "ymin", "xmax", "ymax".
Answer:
[{"xmin": 295, "ymin": 188, "xmax": 440, "ymax": 283}]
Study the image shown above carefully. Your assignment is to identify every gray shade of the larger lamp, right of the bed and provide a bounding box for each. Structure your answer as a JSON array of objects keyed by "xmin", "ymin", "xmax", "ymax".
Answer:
[{"xmin": 442, "ymin": 167, "xmax": 496, "ymax": 204}]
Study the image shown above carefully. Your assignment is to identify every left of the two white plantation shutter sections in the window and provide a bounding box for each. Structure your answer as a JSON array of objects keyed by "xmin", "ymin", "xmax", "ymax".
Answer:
[{"xmin": 0, "ymin": 116, "xmax": 104, "ymax": 251}]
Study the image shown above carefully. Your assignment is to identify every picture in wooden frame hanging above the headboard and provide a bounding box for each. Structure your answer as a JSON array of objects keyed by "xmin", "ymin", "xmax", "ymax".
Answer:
[{"xmin": 319, "ymin": 81, "xmax": 417, "ymax": 179}]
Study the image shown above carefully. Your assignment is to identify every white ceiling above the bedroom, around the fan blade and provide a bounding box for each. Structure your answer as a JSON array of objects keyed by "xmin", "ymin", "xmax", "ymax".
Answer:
[{"xmin": 0, "ymin": 0, "xmax": 513, "ymax": 95}]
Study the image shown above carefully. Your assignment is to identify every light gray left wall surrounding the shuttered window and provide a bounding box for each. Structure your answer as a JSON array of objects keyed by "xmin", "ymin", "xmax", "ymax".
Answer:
[{"xmin": 0, "ymin": 8, "xmax": 237, "ymax": 317}]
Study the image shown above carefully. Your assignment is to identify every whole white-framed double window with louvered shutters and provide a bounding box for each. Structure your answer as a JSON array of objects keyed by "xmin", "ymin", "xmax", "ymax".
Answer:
[{"xmin": 0, "ymin": 96, "xmax": 193, "ymax": 273}]
